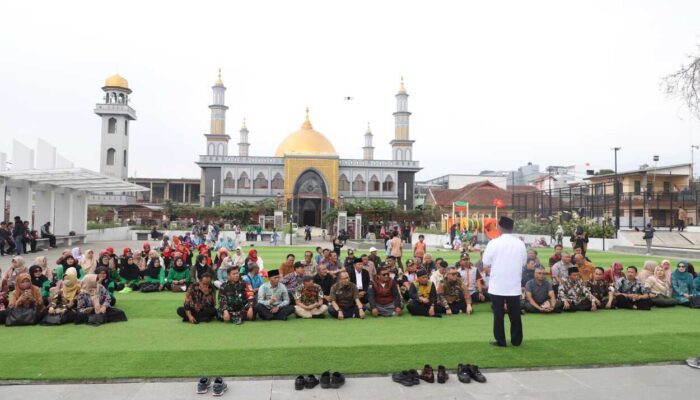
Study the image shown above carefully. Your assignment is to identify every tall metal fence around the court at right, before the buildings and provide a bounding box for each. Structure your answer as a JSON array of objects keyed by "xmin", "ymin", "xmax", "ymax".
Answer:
[{"xmin": 512, "ymin": 183, "xmax": 700, "ymax": 228}]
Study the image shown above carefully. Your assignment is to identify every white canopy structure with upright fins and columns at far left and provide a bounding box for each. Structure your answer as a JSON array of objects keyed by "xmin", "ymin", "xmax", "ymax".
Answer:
[{"xmin": 0, "ymin": 140, "xmax": 148, "ymax": 235}]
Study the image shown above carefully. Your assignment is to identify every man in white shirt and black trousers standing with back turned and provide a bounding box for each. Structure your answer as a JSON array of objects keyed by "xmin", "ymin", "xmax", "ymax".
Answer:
[{"xmin": 483, "ymin": 217, "xmax": 527, "ymax": 347}]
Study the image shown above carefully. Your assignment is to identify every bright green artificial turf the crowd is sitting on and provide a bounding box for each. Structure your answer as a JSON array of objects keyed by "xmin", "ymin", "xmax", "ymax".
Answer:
[{"xmin": 0, "ymin": 247, "xmax": 700, "ymax": 380}]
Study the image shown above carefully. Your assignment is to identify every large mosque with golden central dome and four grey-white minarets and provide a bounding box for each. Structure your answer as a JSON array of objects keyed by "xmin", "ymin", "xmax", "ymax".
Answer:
[{"xmin": 197, "ymin": 71, "xmax": 421, "ymax": 226}]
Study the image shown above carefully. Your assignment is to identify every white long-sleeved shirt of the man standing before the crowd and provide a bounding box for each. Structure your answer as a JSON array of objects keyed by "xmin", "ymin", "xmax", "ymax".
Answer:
[{"xmin": 483, "ymin": 234, "xmax": 527, "ymax": 296}]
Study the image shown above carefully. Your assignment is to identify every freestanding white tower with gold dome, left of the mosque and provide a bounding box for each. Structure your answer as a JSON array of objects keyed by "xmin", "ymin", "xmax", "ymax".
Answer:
[{"xmin": 95, "ymin": 74, "xmax": 136, "ymax": 180}]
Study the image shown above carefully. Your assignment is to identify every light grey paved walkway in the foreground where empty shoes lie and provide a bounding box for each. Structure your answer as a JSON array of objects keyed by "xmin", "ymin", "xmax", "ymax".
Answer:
[{"xmin": 0, "ymin": 365, "xmax": 700, "ymax": 400}]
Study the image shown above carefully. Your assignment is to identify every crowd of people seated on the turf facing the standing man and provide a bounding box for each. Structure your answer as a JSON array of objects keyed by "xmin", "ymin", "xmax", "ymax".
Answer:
[{"xmin": 0, "ymin": 223, "xmax": 700, "ymax": 324}]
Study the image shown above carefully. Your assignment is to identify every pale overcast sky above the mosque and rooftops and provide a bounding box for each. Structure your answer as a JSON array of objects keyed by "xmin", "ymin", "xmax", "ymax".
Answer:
[{"xmin": 0, "ymin": 0, "xmax": 700, "ymax": 179}]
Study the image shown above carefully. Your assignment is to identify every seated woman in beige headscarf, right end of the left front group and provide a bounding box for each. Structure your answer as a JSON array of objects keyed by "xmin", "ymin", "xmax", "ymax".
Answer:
[{"xmin": 75, "ymin": 274, "xmax": 126, "ymax": 324}]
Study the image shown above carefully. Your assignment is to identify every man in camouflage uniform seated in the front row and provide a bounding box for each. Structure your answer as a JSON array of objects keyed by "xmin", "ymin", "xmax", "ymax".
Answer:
[{"xmin": 217, "ymin": 265, "xmax": 255, "ymax": 325}]
